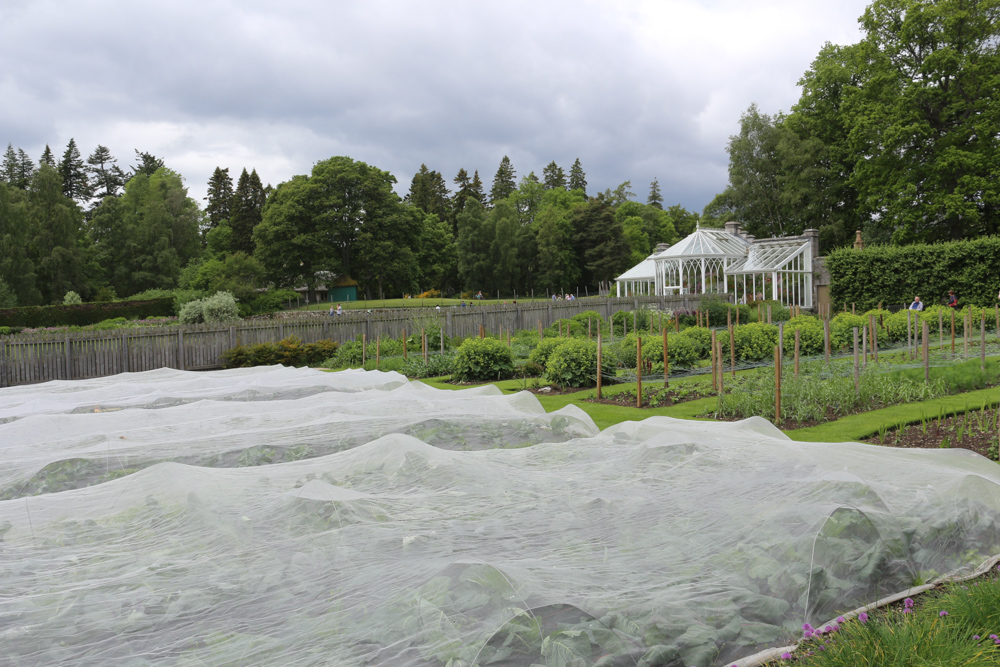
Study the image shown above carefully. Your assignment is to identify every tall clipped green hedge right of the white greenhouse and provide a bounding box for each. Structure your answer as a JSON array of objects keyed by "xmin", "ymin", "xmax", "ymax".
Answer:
[{"xmin": 826, "ymin": 236, "xmax": 1000, "ymax": 310}]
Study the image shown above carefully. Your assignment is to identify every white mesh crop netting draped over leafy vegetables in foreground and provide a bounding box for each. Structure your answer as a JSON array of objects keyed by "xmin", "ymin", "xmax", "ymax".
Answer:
[{"xmin": 0, "ymin": 367, "xmax": 1000, "ymax": 667}]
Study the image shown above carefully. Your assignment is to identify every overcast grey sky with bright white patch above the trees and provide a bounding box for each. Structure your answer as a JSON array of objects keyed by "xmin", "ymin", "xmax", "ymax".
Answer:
[{"xmin": 0, "ymin": 0, "xmax": 866, "ymax": 211}]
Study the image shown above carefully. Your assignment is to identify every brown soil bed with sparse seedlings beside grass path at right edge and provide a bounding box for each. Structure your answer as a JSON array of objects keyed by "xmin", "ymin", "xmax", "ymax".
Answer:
[{"xmin": 863, "ymin": 410, "xmax": 998, "ymax": 460}]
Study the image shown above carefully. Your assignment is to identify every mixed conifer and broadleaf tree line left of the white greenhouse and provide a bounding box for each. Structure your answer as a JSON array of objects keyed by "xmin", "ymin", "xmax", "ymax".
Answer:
[{"xmin": 0, "ymin": 139, "xmax": 699, "ymax": 307}]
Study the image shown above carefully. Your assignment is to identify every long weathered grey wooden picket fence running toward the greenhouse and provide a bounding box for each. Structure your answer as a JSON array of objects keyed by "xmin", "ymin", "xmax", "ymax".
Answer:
[{"xmin": 0, "ymin": 295, "xmax": 724, "ymax": 387}]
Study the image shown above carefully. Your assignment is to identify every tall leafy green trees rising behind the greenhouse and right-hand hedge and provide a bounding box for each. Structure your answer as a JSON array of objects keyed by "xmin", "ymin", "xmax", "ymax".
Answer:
[{"xmin": 705, "ymin": 0, "xmax": 1000, "ymax": 249}]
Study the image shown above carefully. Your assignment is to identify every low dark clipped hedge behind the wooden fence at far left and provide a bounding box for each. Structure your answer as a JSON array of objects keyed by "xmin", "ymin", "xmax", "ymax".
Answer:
[{"xmin": 0, "ymin": 298, "xmax": 174, "ymax": 329}]
